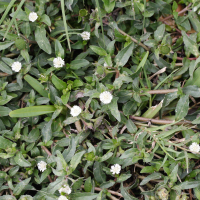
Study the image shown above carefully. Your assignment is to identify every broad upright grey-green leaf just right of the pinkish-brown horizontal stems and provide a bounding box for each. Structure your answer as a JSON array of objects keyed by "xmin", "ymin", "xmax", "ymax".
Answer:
[{"xmin": 175, "ymin": 95, "xmax": 189, "ymax": 120}]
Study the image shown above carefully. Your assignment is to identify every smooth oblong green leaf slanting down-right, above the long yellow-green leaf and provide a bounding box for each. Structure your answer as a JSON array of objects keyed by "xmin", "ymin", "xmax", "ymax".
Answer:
[{"xmin": 24, "ymin": 75, "xmax": 48, "ymax": 97}]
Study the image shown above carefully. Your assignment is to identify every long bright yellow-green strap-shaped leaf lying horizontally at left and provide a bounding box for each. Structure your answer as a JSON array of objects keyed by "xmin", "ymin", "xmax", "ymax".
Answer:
[{"xmin": 9, "ymin": 105, "xmax": 56, "ymax": 117}]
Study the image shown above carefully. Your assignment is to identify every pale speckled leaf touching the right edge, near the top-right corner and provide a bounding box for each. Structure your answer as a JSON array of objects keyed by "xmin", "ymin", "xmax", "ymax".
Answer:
[{"xmin": 181, "ymin": 31, "xmax": 199, "ymax": 57}]
